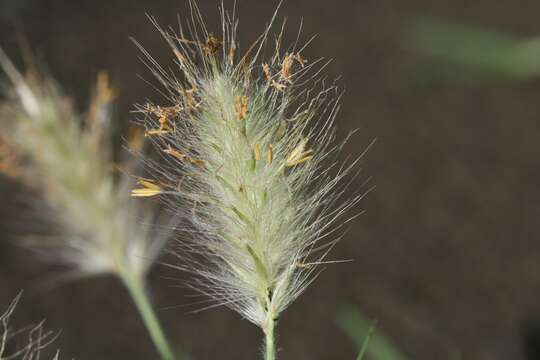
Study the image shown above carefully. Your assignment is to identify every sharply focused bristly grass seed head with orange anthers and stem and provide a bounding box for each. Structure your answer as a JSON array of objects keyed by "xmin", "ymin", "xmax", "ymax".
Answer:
[{"xmin": 133, "ymin": 2, "xmax": 370, "ymax": 360}]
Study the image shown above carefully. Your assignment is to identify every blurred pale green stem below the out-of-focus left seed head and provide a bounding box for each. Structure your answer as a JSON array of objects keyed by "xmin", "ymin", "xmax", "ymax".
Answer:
[{"xmin": 121, "ymin": 274, "xmax": 175, "ymax": 360}]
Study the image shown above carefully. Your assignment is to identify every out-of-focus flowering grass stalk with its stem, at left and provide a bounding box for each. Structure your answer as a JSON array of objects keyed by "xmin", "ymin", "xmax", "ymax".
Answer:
[{"xmin": 0, "ymin": 50, "xmax": 175, "ymax": 360}]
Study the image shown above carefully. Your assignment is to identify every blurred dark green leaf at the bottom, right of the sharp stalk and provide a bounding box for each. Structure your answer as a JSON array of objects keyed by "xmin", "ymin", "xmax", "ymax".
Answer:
[{"xmin": 337, "ymin": 307, "xmax": 407, "ymax": 360}]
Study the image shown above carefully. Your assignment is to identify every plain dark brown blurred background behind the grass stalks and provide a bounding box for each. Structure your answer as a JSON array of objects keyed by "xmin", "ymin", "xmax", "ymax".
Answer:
[{"xmin": 0, "ymin": 0, "xmax": 540, "ymax": 360}]
